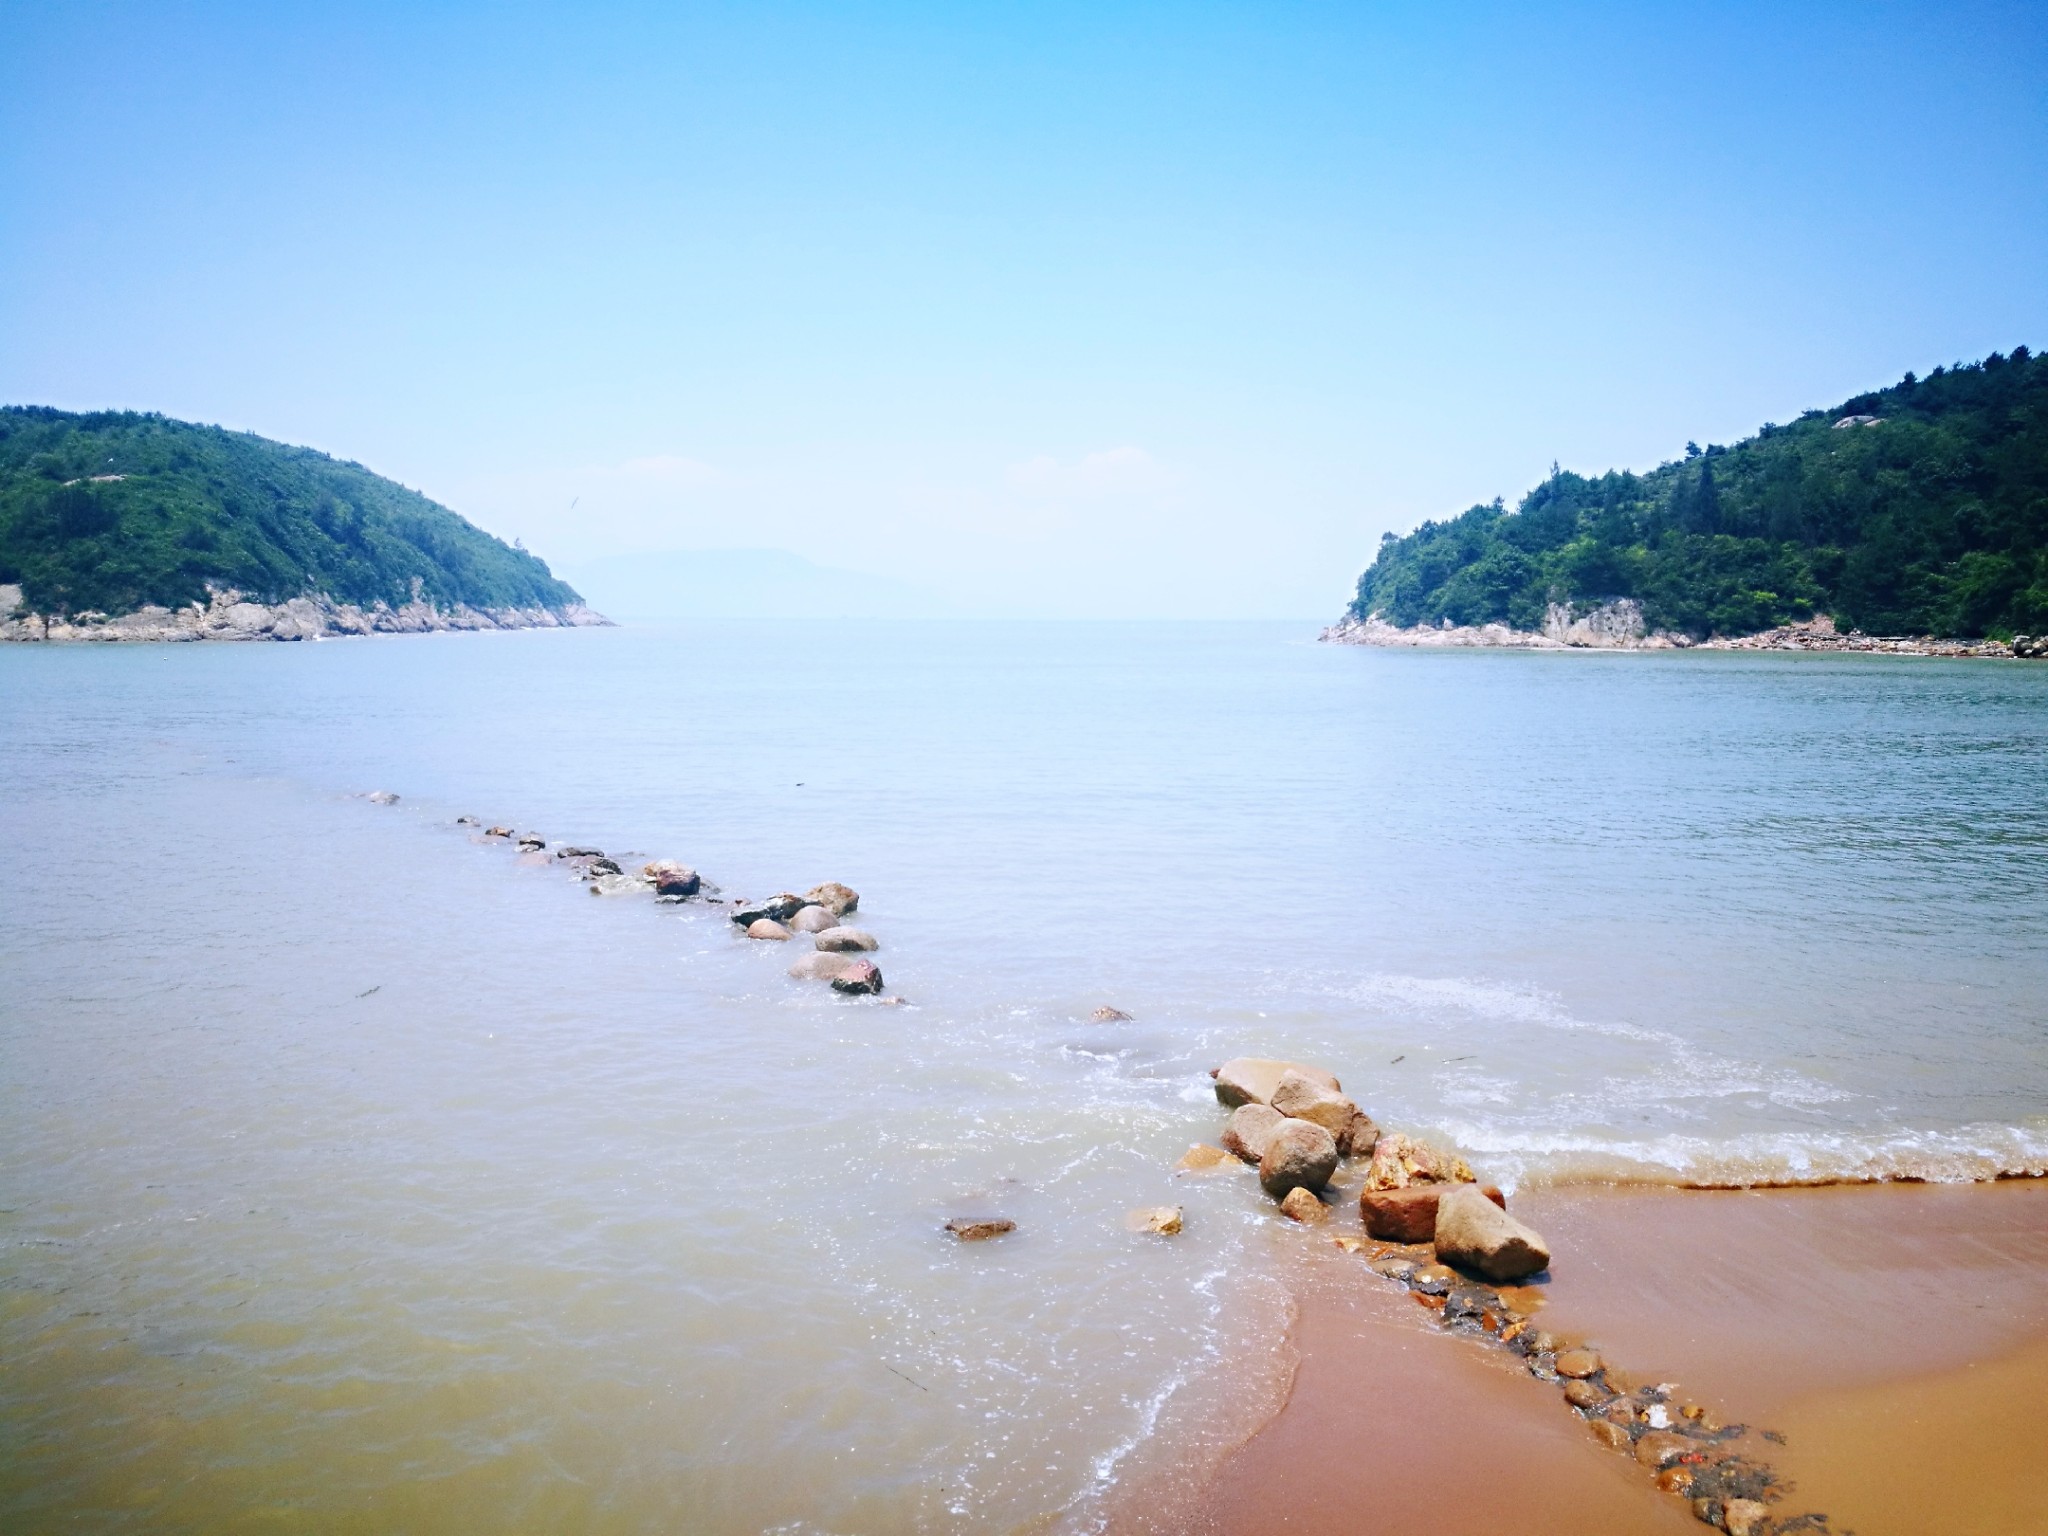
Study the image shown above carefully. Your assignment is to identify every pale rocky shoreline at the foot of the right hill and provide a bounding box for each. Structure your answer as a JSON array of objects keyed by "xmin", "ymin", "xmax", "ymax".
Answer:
[{"xmin": 1317, "ymin": 598, "xmax": 2048, "ymax": 659}]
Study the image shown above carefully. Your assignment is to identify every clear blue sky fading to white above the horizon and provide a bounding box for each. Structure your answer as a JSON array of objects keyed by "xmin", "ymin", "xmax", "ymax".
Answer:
[{"xmin": 0, "ymin": 0, "xmax": 2048, "ymax": 616}]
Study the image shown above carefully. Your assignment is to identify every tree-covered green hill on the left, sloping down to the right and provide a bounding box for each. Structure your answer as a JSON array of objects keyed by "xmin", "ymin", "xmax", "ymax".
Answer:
[{"xmin": 0, "ymin": 415, "xmax": 578, "ymax": 614}]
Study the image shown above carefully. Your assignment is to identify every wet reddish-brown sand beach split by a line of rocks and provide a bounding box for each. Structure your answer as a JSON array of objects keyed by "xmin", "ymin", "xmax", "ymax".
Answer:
[{"xmin": 1138, "ymin": 1182, "xmax": 2048, "ymax": 1536}]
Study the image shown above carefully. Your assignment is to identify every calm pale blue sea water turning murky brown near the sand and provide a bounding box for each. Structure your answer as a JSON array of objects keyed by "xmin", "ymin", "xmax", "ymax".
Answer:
[{"xmin": 0, "ymin": 623, "xmax": 2048, "ymax": 1532}]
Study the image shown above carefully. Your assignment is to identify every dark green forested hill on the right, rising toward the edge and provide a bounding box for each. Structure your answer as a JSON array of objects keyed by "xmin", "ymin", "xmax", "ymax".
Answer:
[{"xmin": 1352, "ymin": 346, "xmax": 2048, "ymax": 639}]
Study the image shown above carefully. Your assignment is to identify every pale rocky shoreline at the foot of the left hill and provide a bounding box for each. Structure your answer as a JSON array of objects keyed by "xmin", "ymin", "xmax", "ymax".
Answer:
[{"xmin": 0, "ymin": 580, "xmax": 612, "ymax": 643}]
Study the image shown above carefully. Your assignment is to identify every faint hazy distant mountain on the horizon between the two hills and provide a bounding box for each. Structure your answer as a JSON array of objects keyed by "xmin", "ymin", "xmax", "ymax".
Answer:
[{"xmin": 552, "ymin": 549, "xmax": 950, "ymax": 618}]
